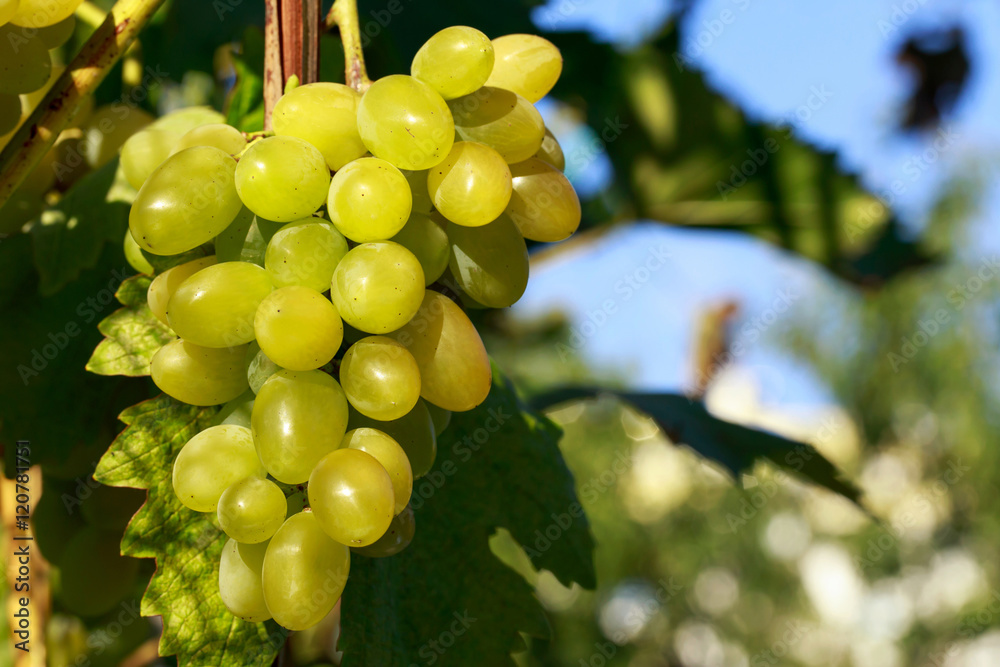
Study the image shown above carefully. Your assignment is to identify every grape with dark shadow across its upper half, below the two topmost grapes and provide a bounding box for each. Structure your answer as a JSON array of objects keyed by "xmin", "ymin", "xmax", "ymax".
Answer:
[{"xmin": 448, "ymin": 86, "xmax": 545, "ymax": 164}]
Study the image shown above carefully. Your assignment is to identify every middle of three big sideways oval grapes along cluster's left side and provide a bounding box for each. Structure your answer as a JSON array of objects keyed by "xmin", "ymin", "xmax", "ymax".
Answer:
[{"xmin": 167, "ymin": 260, "xmax": 272, "ymax": 347}]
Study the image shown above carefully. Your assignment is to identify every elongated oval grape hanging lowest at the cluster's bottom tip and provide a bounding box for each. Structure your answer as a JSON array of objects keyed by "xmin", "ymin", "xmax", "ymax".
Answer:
[{"xmin": 261, "ymin": 512, "xmax": 351, "ymax": 631}]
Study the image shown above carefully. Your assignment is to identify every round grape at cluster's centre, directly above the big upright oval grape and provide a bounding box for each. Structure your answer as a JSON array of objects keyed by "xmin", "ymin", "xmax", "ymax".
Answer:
[{"xmin": 253, "ymin": 285, "xmax": 344, "ymax": 371}]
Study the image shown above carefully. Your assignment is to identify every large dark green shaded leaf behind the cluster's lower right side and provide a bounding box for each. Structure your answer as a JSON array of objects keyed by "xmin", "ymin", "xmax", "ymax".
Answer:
[{"xmin": 339, "ymin": 369, "xmax": 595, "ymax": 667}]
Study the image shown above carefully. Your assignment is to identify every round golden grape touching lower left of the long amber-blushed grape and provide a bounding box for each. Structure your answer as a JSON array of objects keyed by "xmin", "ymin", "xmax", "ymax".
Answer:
[{"xmin": 340, "ymin": 336, "xmax": 420, "ymax": 421}]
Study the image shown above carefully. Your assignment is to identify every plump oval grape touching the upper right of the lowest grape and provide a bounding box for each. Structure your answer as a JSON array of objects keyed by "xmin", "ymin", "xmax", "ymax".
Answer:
[{"xmin": 309, "ymin": 449, "xmax": 395, "ymax": 547}]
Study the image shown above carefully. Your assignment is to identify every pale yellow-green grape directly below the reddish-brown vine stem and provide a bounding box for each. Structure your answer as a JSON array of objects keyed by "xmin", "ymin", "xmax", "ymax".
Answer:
[{"xmin": 272, "ymin": 82, "xmax": 368, "ymax": 171}]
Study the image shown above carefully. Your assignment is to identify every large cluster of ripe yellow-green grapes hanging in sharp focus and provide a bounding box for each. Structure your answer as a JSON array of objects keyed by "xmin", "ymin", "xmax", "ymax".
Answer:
[{"xmin": 127, "ymin": 27, "xmax": 580, "ymax": 630}]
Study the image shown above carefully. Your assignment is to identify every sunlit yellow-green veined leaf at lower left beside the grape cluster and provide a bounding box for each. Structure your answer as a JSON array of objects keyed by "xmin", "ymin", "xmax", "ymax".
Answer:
[{"xmin": 94, "ymin": 395, "xmax": 286, "ymax": 667}]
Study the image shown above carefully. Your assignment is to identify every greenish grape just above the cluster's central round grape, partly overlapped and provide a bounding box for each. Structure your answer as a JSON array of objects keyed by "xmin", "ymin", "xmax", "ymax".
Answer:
[{"xmin": 264, "ymin": 218, "xmax": 347, "ymax": 292}]
